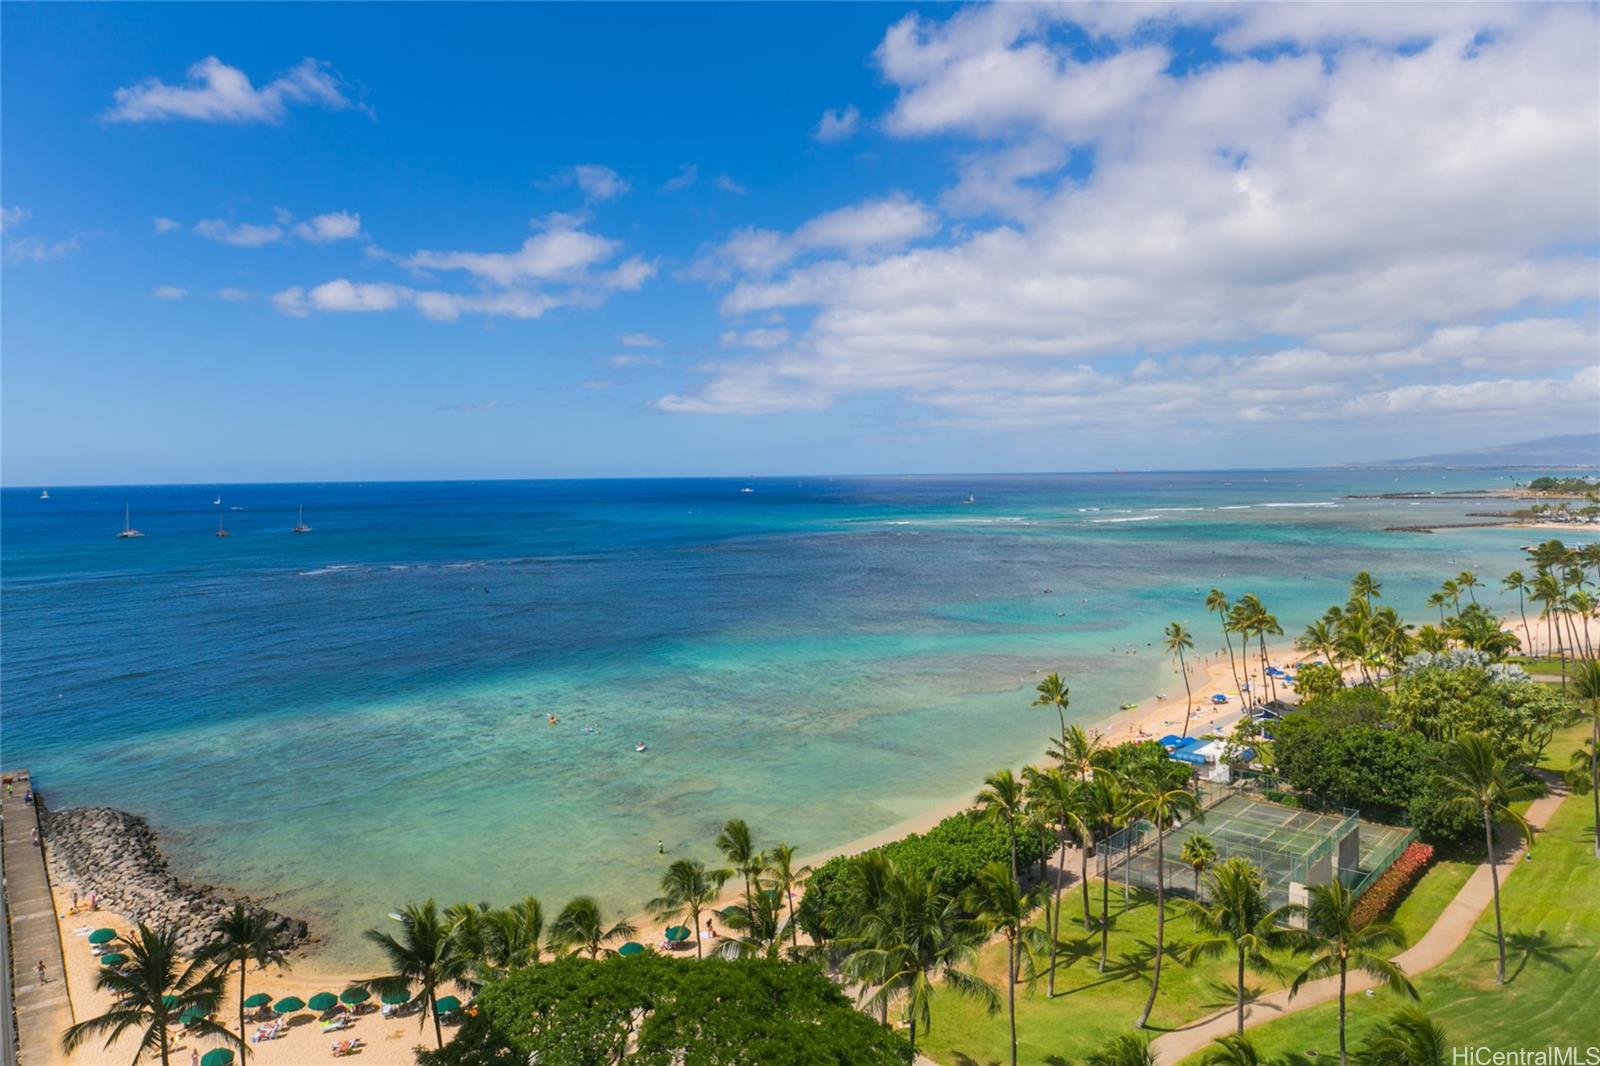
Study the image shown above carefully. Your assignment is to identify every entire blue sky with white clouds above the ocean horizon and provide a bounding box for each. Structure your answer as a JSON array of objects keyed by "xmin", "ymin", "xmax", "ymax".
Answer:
[{"xmin": 0, "ymin": 5, "xmax": 1600, "ymax": 485}]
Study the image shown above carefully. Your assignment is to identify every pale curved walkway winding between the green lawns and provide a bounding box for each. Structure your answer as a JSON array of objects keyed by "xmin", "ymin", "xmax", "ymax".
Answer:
[{"xmin": 1150, "ymin": 776, "xmax": 1566, "ymax": 1066}]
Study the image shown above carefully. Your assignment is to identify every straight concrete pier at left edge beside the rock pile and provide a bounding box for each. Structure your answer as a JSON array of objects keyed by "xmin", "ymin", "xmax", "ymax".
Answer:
[{"xmin": 0, "ymin": 770, "xmax": 75, "ymax": 1066}]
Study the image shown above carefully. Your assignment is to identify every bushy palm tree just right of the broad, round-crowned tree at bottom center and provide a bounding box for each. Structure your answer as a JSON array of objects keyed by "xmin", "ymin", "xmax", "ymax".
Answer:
[{"xmin": 845, "ymin": 868, "xmax": 1000, "ymax": 1053}]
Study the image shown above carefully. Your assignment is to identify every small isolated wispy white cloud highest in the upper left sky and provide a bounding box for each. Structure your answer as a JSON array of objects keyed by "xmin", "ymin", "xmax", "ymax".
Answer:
[{"xmin": 104, "ymin": 56, "xmax": 366, "ymax": 125}]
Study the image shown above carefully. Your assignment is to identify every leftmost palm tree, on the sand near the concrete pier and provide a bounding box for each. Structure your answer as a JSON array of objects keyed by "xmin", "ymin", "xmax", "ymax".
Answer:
[{"xmin": 62, "ymin": 922, "xmax": 233, "ymax": 1066}]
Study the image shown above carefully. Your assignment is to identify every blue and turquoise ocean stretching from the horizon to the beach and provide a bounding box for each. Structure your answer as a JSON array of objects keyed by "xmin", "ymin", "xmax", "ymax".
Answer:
[{"xmin": 0, "ymin": 471, "xmax": 1531, "ymax": 965}]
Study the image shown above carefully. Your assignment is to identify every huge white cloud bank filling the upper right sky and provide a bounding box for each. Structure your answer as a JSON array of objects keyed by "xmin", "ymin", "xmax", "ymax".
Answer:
[{"xmin": 658, "ymin": 5, "xmax": 1600, "ymax": 438}]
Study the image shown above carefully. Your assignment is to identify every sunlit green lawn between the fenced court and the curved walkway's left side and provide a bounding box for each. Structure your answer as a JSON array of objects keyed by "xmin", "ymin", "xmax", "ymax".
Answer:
[{"xmin": 917, "ymin": 880, "xmax": 1280, "ymax": 1066}]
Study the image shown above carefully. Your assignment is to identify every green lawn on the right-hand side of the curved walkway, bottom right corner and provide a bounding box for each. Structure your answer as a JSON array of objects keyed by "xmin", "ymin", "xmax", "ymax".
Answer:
[{"xmin": 1203, "ymin": 787, "xmax": 1600, "ymax": 1061}]
